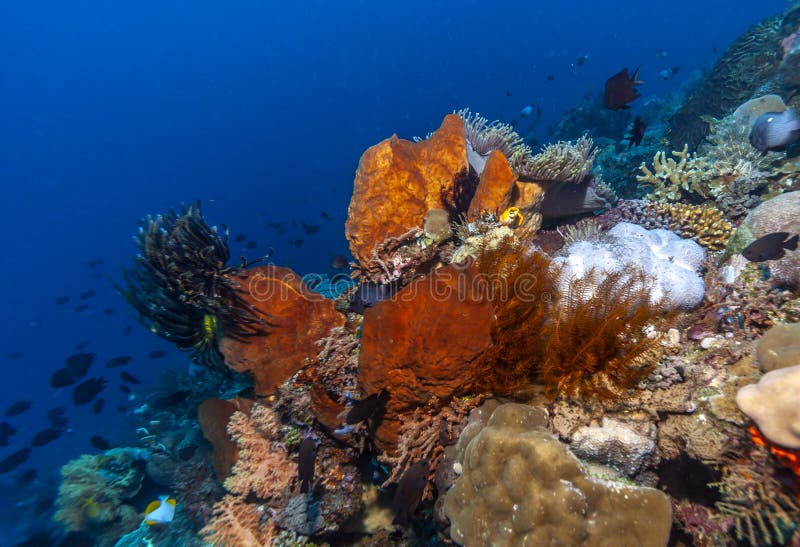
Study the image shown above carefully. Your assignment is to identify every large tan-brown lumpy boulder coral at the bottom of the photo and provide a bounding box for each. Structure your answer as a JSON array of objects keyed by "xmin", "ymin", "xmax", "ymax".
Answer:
[{"xmin": 444, "ymin": 403, "xmax": 672, "ymax": 546}]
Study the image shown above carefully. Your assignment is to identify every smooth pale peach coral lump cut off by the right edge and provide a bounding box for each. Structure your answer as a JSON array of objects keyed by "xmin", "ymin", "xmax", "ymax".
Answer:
[{"xmin": 736, "ymin": 365, "xmax": 800, "ymax": 449}]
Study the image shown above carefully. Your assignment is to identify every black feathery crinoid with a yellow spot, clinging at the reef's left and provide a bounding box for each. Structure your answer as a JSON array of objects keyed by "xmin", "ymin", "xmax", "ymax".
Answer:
[{"xmin": 117, "ymin": 202, "xmax": 270, "ymax": 366}]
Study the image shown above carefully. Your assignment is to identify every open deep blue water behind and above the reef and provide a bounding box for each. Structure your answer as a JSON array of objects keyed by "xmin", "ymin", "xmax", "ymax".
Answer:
[{"xmin": 0, "ymin": 0, "xmax": 788, "ymax": 545}]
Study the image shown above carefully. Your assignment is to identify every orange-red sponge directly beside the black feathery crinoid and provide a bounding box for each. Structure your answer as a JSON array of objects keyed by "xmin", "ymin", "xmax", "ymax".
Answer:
[{"xmin": 219, "ymin": 265, "xmax": 344, "ymax": 395}]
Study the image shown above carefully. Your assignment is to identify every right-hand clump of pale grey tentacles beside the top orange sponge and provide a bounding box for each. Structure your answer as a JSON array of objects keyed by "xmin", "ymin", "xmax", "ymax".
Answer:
[{"xmin": 509, "ymin": 136, "xmax": 597, "ymax": 183}]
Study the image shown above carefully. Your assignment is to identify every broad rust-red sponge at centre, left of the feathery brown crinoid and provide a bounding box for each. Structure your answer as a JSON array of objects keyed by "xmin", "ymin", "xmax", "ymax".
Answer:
[{"xmin": 358, "ymin": 265, "xmax": 492, "ymax": 453}]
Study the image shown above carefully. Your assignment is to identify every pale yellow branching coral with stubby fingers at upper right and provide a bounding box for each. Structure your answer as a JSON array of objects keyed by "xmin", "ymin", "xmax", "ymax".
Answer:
[{"xmin": 636, "ymin": 145, "xmax": 710, "ymax": 201}]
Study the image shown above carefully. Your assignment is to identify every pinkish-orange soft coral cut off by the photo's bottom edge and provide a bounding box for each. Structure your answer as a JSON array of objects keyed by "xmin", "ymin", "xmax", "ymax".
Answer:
[{"xmin": 200, "ymin": 495, "xmax": 278, "ymax": 546}]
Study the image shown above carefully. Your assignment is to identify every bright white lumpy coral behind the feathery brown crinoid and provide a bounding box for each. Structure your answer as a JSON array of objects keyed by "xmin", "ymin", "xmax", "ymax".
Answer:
[{"xmin": 554, "ymin": 222, "xmax": 705, "ymax": 310}]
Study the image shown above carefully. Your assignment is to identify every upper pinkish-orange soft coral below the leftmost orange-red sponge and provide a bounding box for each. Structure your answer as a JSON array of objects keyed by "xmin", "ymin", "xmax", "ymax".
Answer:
[{"xmin": 225, "ymin": 405, "xmax": 297, "ymax": 499}]
